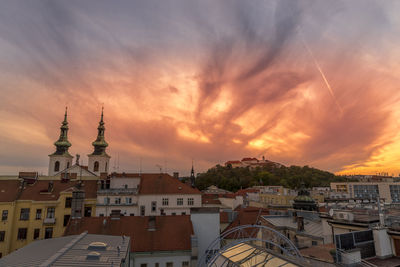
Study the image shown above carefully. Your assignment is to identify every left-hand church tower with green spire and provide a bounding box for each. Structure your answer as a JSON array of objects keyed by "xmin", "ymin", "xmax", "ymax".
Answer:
[{"xmin": 49, "ymin": 108, "xmax": 73, "ymax": 176}]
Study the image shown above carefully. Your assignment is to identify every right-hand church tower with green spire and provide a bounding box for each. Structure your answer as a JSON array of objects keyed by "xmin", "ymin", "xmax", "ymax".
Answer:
[{"xmin": 88, "ymin": 108, "xmax": 110, "ymax": 175}]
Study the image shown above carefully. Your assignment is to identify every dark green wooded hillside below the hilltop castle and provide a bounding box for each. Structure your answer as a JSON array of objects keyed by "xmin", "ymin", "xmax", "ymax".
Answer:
[{"xmin": 196, "ymin": 164, "xmax": 345, "ymax": 192}]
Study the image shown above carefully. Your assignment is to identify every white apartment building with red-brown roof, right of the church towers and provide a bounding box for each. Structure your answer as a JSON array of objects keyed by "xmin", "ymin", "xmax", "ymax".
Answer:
[{"xmin": 96, "ymin": 173, "xmax": 202, "ymax": 216}]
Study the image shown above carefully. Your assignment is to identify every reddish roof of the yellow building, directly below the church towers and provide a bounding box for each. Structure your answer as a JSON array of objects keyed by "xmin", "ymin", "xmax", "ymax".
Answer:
[{"xmin": 18, "ymin": 180, "xmax": 97, "ymax": 201}]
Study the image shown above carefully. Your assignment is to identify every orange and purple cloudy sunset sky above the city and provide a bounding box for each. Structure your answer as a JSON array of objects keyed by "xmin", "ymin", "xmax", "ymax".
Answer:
[{"xmin": 0, "ymin": 0, "xmax": 400, "ymax": 175}]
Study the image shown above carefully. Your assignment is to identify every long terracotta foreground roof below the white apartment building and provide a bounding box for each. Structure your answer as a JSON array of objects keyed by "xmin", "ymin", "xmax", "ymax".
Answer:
[{"xmin": 64, "ymin": 215, "xmax": 193, "ymax": 252}]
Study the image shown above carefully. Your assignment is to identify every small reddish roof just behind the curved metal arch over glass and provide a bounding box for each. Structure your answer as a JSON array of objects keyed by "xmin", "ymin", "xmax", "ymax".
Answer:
[{"xmin": 222, "ymin": 207, "xmax": 269, "ymax": 239}]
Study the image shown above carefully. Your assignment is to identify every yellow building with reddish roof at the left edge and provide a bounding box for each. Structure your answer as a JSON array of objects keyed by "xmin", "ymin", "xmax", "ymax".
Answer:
[{"xmin": 0, "ymin": 177, "xmax": 97, "ymax": 256}]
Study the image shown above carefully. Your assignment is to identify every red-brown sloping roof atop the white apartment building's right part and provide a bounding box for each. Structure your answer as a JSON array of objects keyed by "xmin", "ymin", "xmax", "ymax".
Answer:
[{"xmin": 139, "ymin": 173, "xmax": 201, "ymax": 195}]
